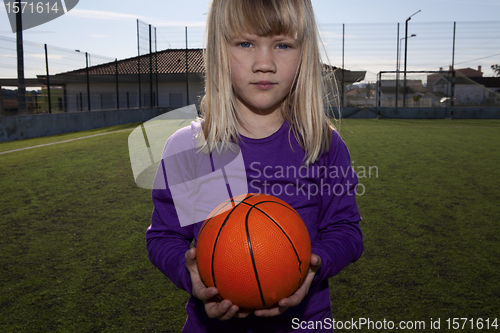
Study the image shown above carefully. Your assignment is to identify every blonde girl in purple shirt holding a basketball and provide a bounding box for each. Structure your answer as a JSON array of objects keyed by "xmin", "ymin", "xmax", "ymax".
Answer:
[{"xmin": 146, "ymin": 0, "xmax": 363, "ymax": 333}]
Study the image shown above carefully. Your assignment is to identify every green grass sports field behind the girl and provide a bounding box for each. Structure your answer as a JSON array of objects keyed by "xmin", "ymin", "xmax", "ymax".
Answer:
[{"xmin": 0, "ymin": 120, "xmax": 500, "ymax": 332}]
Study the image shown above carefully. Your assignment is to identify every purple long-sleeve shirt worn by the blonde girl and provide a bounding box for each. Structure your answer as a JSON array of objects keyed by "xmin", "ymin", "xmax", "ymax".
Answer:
[{"xmin": 146, "ymin": 122, "xmax": 363, "ymax": 333}]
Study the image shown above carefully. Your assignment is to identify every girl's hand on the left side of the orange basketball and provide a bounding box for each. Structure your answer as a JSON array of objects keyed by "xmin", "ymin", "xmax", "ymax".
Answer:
[{"xmin": 185, "ymin": 248, "xmax": 249, "ymax": 320}]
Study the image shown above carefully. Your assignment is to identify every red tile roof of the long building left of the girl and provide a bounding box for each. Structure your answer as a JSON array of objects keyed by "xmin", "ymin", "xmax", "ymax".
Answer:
[{"xmin": 61, "ymin": 49, "xmax": 205, "ymax": 75}]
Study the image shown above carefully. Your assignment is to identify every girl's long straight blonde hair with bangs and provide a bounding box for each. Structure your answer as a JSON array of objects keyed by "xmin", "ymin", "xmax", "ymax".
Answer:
[{"xmin": 201, "ymin": 0, "xmax": 334, "ymax": 165}]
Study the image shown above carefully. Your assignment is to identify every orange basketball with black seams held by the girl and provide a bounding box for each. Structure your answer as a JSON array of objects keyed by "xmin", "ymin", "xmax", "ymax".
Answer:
[{"xmin": 196, "ymin": 194, "xmax": 311, "ymax": 310}]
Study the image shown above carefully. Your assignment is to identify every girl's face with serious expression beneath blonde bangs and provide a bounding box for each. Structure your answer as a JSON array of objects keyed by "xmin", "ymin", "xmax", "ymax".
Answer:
[{"xmin": 228, "ymin": 34, "xmax": 301, "ymax": 115}]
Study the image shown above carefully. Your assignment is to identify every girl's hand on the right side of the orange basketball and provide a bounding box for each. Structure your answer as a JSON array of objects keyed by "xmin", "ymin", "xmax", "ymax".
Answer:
[{"xmin": 254, "ymin": 254, "xmax": 321, "ymax": 317}]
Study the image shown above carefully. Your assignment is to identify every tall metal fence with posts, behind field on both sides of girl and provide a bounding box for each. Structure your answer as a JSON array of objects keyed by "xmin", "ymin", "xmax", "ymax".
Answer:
[{"xmin": 0, "ymin": 20, "xmax": 500, "ymax": 115}]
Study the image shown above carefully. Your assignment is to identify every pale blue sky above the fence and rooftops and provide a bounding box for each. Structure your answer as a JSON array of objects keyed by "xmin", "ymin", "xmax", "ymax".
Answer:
[{"xmin": 0, "ymin": 0, "xmax": 500, "ymax": 76}]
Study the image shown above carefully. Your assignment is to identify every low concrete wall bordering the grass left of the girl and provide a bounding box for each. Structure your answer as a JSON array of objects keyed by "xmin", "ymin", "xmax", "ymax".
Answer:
[{"xmin": 0, "ymin": 108, "xmax": 186, "ymax": 142}]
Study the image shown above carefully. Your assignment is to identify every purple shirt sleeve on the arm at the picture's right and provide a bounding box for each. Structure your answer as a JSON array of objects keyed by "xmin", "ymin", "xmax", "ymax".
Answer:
[{"xmin": 311, "ymin": 132, "xmax": 364, "ymax": 282}]
